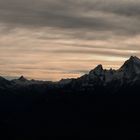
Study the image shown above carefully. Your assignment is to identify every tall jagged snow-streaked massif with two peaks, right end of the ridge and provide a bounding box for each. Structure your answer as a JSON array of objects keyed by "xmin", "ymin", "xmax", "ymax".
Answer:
[{"xmin": 79, "ymin": 56, "xmax": 140, "ymax": 85}]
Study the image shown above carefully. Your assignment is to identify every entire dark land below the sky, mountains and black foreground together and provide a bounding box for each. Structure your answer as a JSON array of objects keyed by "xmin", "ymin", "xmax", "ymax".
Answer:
[{"xmin": 0, "ymin": 57, "xmax": 140, "ymax": 140}]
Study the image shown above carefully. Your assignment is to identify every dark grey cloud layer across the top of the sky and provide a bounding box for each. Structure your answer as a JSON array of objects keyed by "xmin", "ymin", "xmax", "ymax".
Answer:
[{"xmin": 0, "ymin": 0, "xmax": 140, "ymax": 34}]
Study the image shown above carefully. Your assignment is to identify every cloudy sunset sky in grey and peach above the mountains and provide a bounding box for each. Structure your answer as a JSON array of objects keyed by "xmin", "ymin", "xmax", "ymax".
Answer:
[{"xmin": 0, "ymin": 0, "xmax": 140, "ymax": 81}]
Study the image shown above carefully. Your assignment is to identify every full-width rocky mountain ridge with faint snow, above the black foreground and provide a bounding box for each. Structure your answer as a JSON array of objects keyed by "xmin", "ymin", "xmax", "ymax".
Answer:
[{"xmin": 0, "ymin": 56, "xmax": 140, "ymax": 89}]
